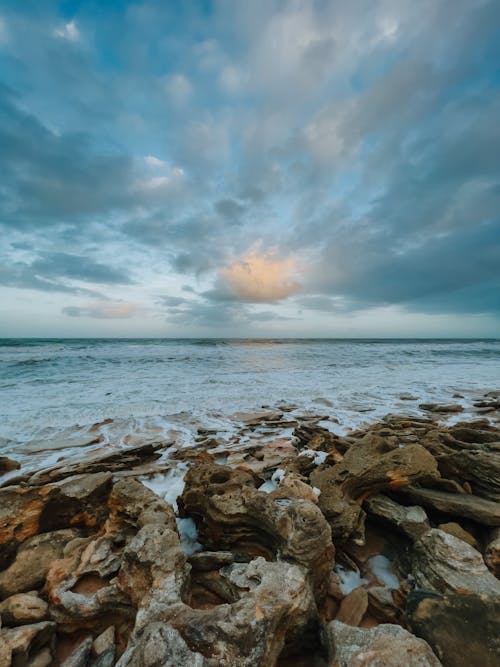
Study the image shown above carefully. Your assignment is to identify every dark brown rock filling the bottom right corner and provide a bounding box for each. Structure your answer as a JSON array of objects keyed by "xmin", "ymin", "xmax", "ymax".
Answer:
[{"xmin": 407, "ymin": 592, "xmax": 500, "ymax": 667}]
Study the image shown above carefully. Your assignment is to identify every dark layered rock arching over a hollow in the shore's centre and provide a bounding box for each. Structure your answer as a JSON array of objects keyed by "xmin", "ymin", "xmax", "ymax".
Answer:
[{"xmin": 178, "ymin": 465, "xmax": 334, "ymax": 587}]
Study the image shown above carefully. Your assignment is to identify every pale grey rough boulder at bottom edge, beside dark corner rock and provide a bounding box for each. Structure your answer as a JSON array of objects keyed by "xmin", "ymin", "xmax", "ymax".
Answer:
[{"xmin": 323, "ymin": 621, "xmax": 441, "ymax": 667}]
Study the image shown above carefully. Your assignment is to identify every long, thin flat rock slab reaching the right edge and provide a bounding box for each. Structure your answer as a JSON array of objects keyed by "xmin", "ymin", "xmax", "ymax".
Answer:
[{"xmin": 399, "ymin": 487, "xmax": 500, "ymax": 526}]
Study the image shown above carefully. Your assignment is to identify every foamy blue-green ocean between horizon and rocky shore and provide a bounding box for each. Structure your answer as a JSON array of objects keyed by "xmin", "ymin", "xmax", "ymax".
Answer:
[{"xmin": 0, "ymin": 339, "xmax": 500, "ymax": 472}]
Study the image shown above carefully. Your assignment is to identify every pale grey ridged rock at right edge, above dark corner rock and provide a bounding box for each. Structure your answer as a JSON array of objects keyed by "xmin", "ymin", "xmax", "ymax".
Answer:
[{"xmin": 412, "ymin": 528, "xmax": 500, "ymax": 594}]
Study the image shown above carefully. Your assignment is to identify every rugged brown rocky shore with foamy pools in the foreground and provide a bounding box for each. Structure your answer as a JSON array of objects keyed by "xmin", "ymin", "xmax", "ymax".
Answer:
[{"xmin": 0, "ymin": 392, "xmax": 500, "ymax": 667}]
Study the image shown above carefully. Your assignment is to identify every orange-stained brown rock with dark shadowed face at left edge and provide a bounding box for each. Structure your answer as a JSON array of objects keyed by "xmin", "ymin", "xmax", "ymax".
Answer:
[{"xmin": 0, "ymin": 472, "xmax": 111, "ymax": 569}]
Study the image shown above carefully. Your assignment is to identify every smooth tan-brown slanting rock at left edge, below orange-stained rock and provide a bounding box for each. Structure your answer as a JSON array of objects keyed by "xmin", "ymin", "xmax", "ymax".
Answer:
[{"xmin": 0, "ymin": 529, "xmax": 79, "ymax": 599}]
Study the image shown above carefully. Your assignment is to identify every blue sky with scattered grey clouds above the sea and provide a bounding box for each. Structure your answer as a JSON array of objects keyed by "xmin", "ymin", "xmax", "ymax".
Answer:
[{"xmin": 0, "ymin": 0, "xmax": 500, "ymax": 337}]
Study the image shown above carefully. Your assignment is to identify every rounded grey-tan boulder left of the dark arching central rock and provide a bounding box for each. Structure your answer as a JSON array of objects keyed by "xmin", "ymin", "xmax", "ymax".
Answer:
[{"xmin": 118, "ymin": 524, "xmax": 188, "ymax": 609}]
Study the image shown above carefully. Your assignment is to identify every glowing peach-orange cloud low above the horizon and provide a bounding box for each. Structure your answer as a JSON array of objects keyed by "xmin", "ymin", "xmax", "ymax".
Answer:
[{"xmin": 219, "ymin": 253, "xmax": 299, "ymax": 302}]
